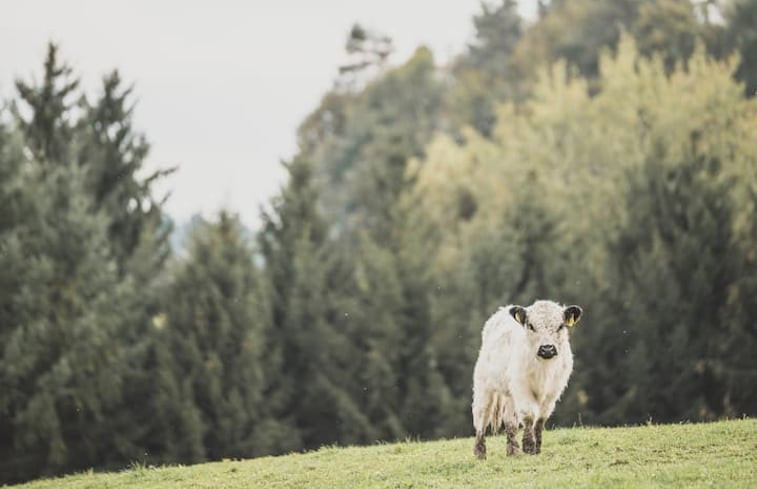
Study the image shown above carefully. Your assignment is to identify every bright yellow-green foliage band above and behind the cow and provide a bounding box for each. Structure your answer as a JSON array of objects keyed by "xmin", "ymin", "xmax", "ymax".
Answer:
[{"xmin": 410, "ymin": 36, "xmax": 757, "ymax": 278}]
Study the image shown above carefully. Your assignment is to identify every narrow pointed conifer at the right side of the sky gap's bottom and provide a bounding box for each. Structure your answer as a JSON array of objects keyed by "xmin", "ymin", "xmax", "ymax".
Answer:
[{"xmin": 258, "ymin": 158, "xmax": 369, "ymax": 450}]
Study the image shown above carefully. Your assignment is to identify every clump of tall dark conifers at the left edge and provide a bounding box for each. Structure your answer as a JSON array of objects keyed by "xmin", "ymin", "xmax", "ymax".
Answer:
[{"xmin": 0, "ymin": 45, "xmax": 172, "ymax": 480}]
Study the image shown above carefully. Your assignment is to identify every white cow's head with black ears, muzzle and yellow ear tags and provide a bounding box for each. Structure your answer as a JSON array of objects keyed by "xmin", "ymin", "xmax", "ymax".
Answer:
[{"xmin": 510, "ymin": 301, "xmax": 582, "ymax": 360}]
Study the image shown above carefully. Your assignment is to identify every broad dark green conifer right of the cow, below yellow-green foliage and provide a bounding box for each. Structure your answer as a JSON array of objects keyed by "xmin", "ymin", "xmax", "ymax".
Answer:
[{"xmin": 594, "ymin": 149, "xmax": 743, "ymax": 422}]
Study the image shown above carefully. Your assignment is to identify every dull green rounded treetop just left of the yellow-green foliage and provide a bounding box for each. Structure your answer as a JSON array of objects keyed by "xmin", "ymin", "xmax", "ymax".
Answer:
[{"xmin": 312, "ymin": 48, "xmax": 442, "ymax": 239}]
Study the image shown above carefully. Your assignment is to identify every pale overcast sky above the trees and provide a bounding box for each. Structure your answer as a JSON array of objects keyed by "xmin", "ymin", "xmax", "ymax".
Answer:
[{"xmin": 0, "ymin": 0, "xmax": 535, "ymax": 226}]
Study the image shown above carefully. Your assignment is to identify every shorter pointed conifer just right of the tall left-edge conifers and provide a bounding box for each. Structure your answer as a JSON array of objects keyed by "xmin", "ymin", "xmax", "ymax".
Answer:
[{"xmin": 149, "ymin": 212, "xmax": 271, "ymax": 462}]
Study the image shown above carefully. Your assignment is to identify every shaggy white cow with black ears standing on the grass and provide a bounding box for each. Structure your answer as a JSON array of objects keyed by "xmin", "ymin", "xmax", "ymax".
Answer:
[{"xmin": 472, "ymin": 301, "xmax": 582, "ymax": 459}]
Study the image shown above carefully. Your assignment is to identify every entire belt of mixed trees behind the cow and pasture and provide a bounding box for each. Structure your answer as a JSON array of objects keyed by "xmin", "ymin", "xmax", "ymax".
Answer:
[{"xmin": 0, "ymin": 0, "xmax": 757, "ymax": 483}]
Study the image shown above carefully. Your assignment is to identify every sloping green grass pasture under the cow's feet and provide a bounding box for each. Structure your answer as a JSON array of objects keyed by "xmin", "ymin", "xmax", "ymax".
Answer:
[{"xmin": 7, "ymin": 419, "xmax": 757, "ymax": 489}]
